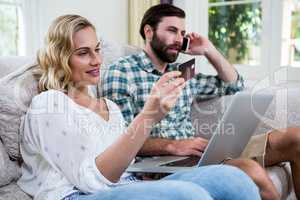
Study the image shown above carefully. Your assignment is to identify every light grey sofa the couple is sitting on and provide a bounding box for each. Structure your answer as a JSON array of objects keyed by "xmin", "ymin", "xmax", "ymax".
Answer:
[{"xmin": 0, "ymin": 41, "xmax": 300, "ymax": 200}]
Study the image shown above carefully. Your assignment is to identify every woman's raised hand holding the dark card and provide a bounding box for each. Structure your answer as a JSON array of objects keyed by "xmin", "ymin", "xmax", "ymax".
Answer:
[{"xmin": 141, "ymin": 71, "xmax": 185, "ymax": 123}]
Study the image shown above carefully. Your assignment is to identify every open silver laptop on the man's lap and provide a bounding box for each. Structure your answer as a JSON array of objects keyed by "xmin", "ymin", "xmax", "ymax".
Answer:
[{"xmin": 126, "ymin": 92, "xmax": 273, "ymax": 173}]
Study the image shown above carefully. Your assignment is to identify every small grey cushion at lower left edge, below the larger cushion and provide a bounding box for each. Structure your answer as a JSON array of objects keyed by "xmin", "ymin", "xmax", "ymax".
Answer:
[{"xmin": 0, "ymin": 141, "xmax": 20, "ymax": 186}]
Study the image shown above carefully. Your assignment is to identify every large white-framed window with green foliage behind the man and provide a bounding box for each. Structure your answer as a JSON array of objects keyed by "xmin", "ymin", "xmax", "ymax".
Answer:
[{"xmin": 174, "ymin": 0, "xmax": 300, "ymax": 83}]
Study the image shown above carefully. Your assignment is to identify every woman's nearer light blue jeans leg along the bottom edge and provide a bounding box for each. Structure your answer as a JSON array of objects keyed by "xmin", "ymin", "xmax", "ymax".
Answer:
[{"xmin": 74, "ymin": 180, "xmax": 213, "ymax": 200}]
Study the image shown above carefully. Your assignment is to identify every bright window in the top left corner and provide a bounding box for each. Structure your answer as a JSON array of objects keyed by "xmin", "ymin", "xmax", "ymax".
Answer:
[{"xmin": 0, "ymin": 0, "xmax": 24, "ymax": 56}]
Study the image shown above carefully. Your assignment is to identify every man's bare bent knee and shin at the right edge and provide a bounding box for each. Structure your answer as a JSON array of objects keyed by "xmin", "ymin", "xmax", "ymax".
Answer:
[{"xmin": 265, "ymin": 128, "xmax": 300, "ymax": 199}]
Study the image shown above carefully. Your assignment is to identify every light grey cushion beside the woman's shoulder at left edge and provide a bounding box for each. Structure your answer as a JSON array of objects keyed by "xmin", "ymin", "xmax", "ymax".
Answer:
[{"xmin": 0, "ymin": 63, "xmax": 37, "ymax": 160}]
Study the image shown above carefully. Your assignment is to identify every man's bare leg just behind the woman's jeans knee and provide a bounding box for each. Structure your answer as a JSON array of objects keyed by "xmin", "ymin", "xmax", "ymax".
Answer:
[{"xmin": 226, "ymin": 159, "xmax": 280, "ymax": 200}]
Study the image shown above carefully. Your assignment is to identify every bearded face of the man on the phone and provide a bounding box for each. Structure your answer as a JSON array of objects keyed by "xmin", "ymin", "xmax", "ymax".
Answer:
[{"xmin": 150, "ymin": 17, "xmax": 185, "ymax": 63}]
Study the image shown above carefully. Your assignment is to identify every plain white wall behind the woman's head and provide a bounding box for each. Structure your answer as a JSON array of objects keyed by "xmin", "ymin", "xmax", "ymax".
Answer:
[{"xmin": 25, "ymin": 0, "xmax": 128, "ymax": 55}]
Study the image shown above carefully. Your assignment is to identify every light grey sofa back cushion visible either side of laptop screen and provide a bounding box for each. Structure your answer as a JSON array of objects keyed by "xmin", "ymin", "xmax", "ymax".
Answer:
[{"xmin": 191, "ymin": 86, "xmax": 300, "ymax": 138}]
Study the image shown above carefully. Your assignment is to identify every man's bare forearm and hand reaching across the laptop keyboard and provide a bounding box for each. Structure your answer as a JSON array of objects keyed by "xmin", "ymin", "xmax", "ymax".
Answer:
[{"xmin": 138, "ymin": 138, "xmax": 208, "ymax": 156}]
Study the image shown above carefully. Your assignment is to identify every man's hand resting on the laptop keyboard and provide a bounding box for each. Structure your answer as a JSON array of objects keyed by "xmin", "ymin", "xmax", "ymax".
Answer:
[{"xmin": 167, "ymin": 137, "xmax": 208, "ymax": 157}]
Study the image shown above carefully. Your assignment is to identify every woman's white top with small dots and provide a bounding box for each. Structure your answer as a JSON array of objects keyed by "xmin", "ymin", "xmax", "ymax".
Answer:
[{"xmin": 18, "ymin": 90, "xmax": 137, "ymax": 200}]
